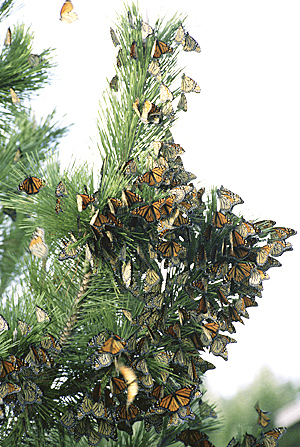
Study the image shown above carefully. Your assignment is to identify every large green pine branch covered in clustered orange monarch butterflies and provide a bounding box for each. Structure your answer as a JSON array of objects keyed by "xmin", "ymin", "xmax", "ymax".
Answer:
[{"xmin": 0, "ymin": 5, "xmax": 295, "ymax": 447}]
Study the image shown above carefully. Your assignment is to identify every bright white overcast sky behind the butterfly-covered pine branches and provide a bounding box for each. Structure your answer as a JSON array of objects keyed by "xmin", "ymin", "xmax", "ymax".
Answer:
[{"xmin": 0, "ymin": 0, "xmax": 300, "ymax": 396}]
